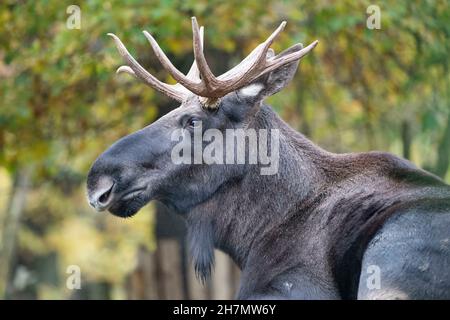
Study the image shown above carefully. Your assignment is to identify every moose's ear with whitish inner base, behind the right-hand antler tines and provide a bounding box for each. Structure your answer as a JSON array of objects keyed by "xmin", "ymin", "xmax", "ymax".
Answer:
[{"xmin": 239, "ymin": 43, "xmax": 303, "ymax": 100}]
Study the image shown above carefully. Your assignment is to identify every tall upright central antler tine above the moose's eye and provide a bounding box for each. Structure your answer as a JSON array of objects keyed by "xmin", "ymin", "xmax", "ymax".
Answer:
[{"xmin": 188, "ymin": 17, "xmax": 220, "ymax": 98}]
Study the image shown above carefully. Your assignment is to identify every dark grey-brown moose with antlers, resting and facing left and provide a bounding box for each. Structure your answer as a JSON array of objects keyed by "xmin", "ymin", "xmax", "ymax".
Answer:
[{"xmin": 87, "ymin": 17, "xmax": 450, "ymax": 299}]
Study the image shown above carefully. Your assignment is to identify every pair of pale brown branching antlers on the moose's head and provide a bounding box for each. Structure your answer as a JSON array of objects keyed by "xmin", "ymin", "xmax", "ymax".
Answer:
[{"xmin": 108, "ymin": 17, "xmax": 318, "ymax": 108}]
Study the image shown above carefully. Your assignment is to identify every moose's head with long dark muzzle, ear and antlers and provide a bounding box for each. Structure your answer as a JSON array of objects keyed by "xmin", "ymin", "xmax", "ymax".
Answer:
[{"xmin": 87, "ymin": 17, "xmax": 318, "ymax": 217}]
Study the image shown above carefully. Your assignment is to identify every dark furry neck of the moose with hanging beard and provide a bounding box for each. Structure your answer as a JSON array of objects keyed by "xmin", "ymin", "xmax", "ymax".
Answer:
[{"xmin": 187, "ymin": 105, "xmax": 333, "ymax": 278}]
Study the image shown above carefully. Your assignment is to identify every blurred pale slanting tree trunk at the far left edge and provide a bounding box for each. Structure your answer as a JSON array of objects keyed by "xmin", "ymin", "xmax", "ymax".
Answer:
[{"xmin": 0, "ymin": 168, "xmax": 31, "ymax": 298}]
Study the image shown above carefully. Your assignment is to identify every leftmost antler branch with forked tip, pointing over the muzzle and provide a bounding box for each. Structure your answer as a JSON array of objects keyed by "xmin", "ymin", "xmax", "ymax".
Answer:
[{"xmin": 108, "ymin": 33, "xmax": 185, "ymax": 102}]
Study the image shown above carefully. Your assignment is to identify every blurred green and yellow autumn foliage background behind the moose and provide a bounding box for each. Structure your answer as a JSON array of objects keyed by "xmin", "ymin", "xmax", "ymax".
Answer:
[{"xmin": 0, "ymin": 0, "xmax": 450, "ymax": 299}]
